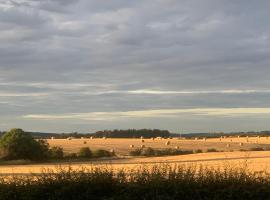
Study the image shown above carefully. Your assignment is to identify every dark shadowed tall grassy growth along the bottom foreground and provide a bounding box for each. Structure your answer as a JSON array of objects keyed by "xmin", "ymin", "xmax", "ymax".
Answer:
[{"xmin": 0, "ymin": 165, "xmax": 270, "ymax": 200}]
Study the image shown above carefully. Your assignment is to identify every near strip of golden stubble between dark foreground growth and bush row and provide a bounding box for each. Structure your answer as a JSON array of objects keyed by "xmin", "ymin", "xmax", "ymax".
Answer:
[{"xmin": 0, "ymin": 151, "xmax": 270, "ymax": 174}]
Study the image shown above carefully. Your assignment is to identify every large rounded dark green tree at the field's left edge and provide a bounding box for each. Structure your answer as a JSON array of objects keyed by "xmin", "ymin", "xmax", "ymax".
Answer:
[{"xmin": 0, "ymin": 128, "xmax": 49, "ymax": 160}]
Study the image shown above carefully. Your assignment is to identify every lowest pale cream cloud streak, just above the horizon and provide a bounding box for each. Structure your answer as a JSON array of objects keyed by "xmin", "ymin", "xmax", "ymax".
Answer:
[{"xmin": 22, "ymin": 108, "xmax": 270, "ymax": 121}]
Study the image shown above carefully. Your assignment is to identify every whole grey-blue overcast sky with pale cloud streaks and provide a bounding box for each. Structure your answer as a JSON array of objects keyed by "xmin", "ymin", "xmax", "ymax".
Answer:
[{"xmin": 0, "ymin": 0, "xmax": 270, "ymax": 133}]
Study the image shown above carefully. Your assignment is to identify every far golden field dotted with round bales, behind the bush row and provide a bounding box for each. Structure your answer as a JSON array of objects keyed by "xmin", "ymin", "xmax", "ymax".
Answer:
[{"xmin": 47, "ymin": 137, "xmax": 270, "ymax": 156}]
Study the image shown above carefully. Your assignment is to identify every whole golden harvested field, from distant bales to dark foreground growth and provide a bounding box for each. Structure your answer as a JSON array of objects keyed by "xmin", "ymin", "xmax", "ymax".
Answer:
[{"xmin": 0, "ymin": 137, "xmax": 270, "ymax": 174}]
